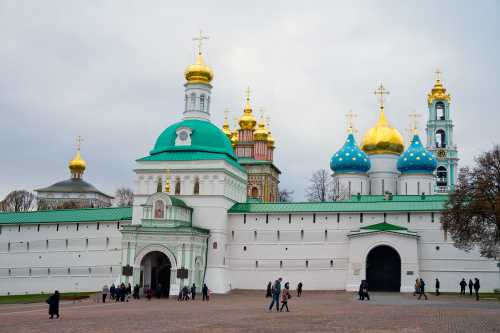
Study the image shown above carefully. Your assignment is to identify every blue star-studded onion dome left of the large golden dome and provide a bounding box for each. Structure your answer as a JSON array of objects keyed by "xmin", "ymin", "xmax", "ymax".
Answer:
[{"xmin": 330, "ymin": 133, "xmax": 371, "ymax": 174}]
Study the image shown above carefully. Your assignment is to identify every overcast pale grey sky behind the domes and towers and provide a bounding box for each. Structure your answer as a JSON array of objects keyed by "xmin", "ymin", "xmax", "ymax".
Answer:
[{"xmin": 0, "ymin": 0, "xmax": 500, "ymax": 200}]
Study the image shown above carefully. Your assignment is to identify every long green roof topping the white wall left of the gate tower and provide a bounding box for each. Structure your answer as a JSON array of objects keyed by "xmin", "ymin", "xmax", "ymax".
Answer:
[{"xmin": 0, "ymin": 207, "xmax": 132, "ymax": 224}]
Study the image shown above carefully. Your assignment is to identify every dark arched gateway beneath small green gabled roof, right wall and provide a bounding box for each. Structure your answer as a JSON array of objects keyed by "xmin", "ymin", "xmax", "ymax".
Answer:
[{"xmin": 366, "ymin": 245, "xmax": 401, "ymax": 292}]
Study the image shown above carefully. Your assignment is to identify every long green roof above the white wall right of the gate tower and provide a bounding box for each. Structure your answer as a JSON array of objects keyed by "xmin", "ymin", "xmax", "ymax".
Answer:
[{"xmin": 229, "ymin": 195, "xmax": 448, "ymax": 214}]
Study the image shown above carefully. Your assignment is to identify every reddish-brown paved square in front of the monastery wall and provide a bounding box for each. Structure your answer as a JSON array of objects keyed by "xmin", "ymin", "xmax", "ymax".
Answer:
[{"xmin": 0, "ymin": 291, "xmax": 500, "ymax": 333}]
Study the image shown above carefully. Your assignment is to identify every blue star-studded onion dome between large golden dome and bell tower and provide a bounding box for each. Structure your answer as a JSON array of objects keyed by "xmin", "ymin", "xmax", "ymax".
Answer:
[{"xmin": 398, "ymin": 134, "xmax": 437, "ymax": 174}]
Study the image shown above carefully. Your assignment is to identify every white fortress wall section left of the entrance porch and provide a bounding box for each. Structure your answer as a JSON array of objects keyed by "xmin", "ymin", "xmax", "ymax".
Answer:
[{"xmin": 0, "ymin": 221, "xmax": 130, "ymax": 295}]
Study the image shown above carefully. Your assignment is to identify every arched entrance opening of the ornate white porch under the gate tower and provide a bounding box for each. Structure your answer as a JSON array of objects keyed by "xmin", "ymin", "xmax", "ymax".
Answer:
[{"xmin": 141, "ymin": 251, "xmax": 172, "ymax": 297}]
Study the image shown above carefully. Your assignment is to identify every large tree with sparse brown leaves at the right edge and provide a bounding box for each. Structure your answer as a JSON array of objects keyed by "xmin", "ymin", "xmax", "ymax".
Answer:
[{"xmin": 441, "ymin": 145, "xmax": 500, "ymax": 259}]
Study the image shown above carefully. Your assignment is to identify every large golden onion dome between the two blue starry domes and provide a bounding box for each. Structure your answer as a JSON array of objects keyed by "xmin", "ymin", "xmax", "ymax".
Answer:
[{"xmin": 361, "ymin": 106, "xmax": 404, "ymax": 155}]
